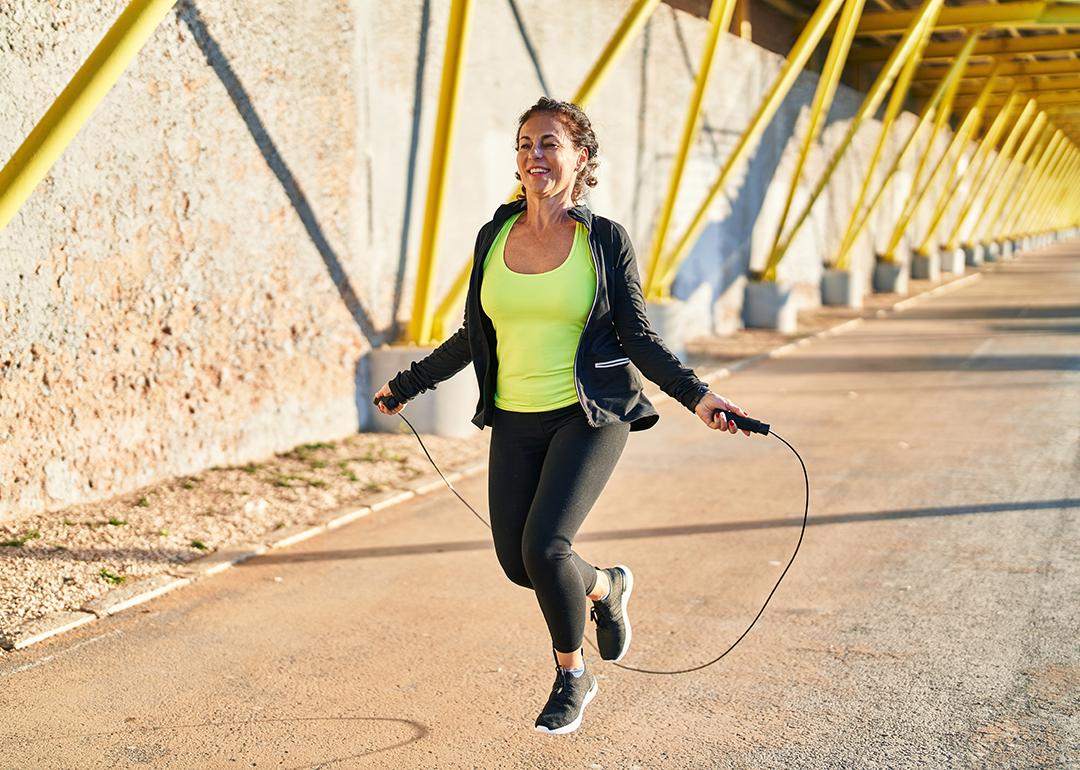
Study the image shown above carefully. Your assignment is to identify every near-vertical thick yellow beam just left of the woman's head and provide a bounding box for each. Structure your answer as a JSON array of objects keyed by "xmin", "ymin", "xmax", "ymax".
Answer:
[{"xmin": 406, "ymin": 0, "xmax": 472, "ymax": 345}]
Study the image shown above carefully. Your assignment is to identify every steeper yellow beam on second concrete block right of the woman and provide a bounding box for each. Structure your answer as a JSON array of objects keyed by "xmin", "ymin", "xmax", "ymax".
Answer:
[{"xmin": 759, "ymin": 0, "xmax": 868, "ymax": 281}]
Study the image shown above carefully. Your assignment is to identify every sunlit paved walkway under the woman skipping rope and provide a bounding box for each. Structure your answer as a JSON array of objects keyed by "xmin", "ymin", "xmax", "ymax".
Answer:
[{"xmin": 0, "ymin": 242, "xmax": 1080, "ymax": 770}]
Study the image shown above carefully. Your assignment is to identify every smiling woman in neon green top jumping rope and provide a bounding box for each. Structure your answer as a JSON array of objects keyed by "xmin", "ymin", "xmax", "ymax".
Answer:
[{"xmin": 376, "ymin": 97, "xmax": 748, "ymax": 733}]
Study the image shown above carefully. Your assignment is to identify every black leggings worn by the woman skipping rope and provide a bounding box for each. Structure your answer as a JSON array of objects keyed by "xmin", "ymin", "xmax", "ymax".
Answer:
[{"xmin": 488, "ymin": 404, "xmax": 630, "ymax": 652}]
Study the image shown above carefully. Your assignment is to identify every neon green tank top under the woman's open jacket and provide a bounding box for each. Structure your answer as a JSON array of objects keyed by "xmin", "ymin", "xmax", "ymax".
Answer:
[{"xmin": 480, "ymin": 212, "xmax": 596, "ymax": 411}]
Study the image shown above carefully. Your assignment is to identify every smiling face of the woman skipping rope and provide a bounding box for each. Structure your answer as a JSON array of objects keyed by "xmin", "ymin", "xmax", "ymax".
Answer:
[{"xmin": 517, "ymin": 112, "xmax": 589, "ymax": 199}]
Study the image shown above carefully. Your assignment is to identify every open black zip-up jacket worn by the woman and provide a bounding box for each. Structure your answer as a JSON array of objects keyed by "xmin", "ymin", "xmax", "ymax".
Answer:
[{"xmin": 390, "ymin": 200, "xmax": 708, "ymax": 431}]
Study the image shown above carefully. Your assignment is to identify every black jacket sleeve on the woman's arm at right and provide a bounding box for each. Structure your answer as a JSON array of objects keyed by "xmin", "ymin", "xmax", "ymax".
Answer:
[{"xmin": 611, "ymin": 222, "xmax": 708, "ymax": 411}]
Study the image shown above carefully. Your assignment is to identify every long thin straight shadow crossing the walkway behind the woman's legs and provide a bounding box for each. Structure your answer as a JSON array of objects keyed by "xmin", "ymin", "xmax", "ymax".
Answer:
[{"xmin": 237, "ymin": 498, "xmax": 1080, "ymax": 567}]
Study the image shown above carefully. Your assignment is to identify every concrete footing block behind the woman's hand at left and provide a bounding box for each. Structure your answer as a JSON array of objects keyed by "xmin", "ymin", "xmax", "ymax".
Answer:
[{"xmin": 365, "ymin": 346, "xmax": 480, "ymax": 438}]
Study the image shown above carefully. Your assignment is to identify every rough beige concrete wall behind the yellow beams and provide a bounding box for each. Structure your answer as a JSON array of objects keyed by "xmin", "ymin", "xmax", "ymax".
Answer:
[{"xmin": 0, "ymin": 0, "xmax": 972, "ymax": 517}]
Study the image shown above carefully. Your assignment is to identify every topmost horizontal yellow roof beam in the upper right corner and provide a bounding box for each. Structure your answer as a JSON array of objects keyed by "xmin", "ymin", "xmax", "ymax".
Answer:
[{"xmin": 859, "ymin": 2, "xmax": 1080, "ymax": 35}]
